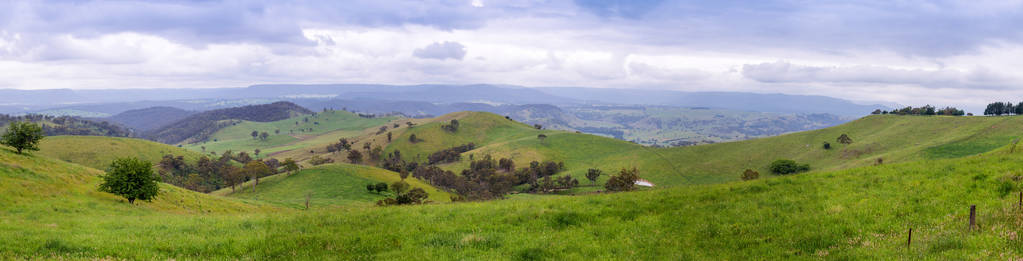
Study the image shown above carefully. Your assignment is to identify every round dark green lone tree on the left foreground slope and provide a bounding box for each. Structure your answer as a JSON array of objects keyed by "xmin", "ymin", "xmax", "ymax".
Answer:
[{"xmin": 99, "ymin": 158, "xmax": 160, "ymax": 204}]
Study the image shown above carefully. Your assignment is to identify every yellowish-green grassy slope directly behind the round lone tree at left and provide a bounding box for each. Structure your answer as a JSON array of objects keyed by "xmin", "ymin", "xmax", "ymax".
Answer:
[{"xmin": 35, "ymin": 136, "xmax": 202, "ymax": 170}]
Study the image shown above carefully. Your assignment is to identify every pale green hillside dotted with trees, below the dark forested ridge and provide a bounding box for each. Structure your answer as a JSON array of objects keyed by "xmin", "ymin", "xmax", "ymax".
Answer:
[{"xmin": 185, "ymin": 111, "xmax": 394, "ymax": 156}]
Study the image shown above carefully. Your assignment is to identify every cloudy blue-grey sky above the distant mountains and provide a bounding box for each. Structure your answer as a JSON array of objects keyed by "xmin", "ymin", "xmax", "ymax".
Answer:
[{"xmin": 0, "ymin": 0, "xmax": 1023, "ymax": 107}]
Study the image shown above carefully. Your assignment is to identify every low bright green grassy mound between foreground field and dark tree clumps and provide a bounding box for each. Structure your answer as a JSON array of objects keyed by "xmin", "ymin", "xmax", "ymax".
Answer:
[{"xmin": 214, "ymin": 164, "xmax": 451, "ymax": 208}]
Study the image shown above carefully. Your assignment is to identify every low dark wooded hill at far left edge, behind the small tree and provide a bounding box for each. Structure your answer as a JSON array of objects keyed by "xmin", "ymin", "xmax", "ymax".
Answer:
[{"xmin": 0, "ymin": 115, "xmax": 132, "ymax": 137}]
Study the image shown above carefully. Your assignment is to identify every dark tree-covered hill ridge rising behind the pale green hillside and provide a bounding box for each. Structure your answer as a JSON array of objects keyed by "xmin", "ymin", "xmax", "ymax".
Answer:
[{"xmin": 143, "ymin": 101, "xmax": 313, "ymax": 143}]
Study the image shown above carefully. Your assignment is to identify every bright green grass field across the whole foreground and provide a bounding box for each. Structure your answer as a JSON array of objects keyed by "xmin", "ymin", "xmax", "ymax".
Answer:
[{"xmin": 6, "ymin": 142, "xmax": 1023, "ymax": 260}]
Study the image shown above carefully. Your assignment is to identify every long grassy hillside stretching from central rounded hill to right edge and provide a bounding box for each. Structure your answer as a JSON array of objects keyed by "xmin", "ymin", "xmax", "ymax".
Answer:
[{"xmin": 387, "ymin": 113, "xmax": 1023, "ymax": 186}]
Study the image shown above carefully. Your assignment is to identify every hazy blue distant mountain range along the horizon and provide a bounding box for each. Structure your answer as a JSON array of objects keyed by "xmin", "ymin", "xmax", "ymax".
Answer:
[{"xmin": 0, "ymin": 84, "xmax": 888, "ymax": 117}]
